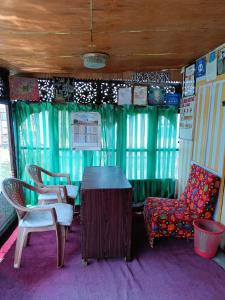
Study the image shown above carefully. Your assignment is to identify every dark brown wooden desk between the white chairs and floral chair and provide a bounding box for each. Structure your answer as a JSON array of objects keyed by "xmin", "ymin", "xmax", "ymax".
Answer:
[{"xmin": 81, "ymin": 167, "xmax": 132, "ymax": 264}]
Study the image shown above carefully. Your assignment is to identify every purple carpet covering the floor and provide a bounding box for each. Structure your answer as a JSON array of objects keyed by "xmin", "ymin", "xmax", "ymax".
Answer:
[{"xmin": 0, "ymin": 218, "xmax": 225, "ymax": 300}]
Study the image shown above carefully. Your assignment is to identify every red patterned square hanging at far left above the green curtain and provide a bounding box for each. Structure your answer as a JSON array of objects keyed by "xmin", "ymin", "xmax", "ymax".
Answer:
[{"xmin": 9, "ymin": 77, "xmax": 39, "ymax": 101}]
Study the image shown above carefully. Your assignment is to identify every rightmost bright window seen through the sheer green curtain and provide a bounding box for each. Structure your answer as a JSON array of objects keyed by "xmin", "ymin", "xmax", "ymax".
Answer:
[{"xmin": 126, "ymin": 113, "xmax": 178, "ymax": 179}]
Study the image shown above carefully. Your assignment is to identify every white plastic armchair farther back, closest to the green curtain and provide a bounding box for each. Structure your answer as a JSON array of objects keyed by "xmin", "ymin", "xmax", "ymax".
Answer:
[{"xmin": 26, "ymin": 165, "xmax": 78, "ymax": 209}]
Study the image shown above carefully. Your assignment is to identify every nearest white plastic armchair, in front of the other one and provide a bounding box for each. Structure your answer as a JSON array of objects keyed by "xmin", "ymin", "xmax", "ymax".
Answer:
[{"xmin": 2, "ymin": 178, "xmax": 73, "ymax": 268}]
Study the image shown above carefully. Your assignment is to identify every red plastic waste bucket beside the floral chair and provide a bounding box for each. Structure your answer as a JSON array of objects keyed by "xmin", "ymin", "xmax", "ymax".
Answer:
[{"xmin": 193, "ymin": 219, "xmax": 225, "ymax": 258}]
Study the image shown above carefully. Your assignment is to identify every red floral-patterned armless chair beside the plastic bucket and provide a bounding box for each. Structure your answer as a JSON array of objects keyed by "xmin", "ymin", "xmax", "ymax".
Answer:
[{"xmin": 144, "ymin": 164, "xmax": 220, "ymax": 248}]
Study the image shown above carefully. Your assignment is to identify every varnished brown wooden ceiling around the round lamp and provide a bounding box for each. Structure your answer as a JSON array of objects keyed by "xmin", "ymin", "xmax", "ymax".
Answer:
[{"xmin": 0, "ymin": 0, "xmax": 225, "ymax": 74}]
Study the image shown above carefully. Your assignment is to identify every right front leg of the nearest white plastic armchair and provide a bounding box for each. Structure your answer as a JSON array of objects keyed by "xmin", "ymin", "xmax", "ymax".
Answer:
[{"xmin": 56, "ymin": 225, "xmax": 66, "ymax": 268}]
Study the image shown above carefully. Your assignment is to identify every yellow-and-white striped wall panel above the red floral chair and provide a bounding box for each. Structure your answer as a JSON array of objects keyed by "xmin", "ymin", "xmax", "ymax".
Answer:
[{"xmin": 193, "ymin": 80, "xmax": 225, "ymax": 176}]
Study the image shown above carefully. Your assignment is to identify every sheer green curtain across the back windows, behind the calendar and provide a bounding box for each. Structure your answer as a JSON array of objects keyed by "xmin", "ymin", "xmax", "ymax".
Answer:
[{"xmin": 13, "ymin": 101, "xmax": 177, "ymax": 205}]
